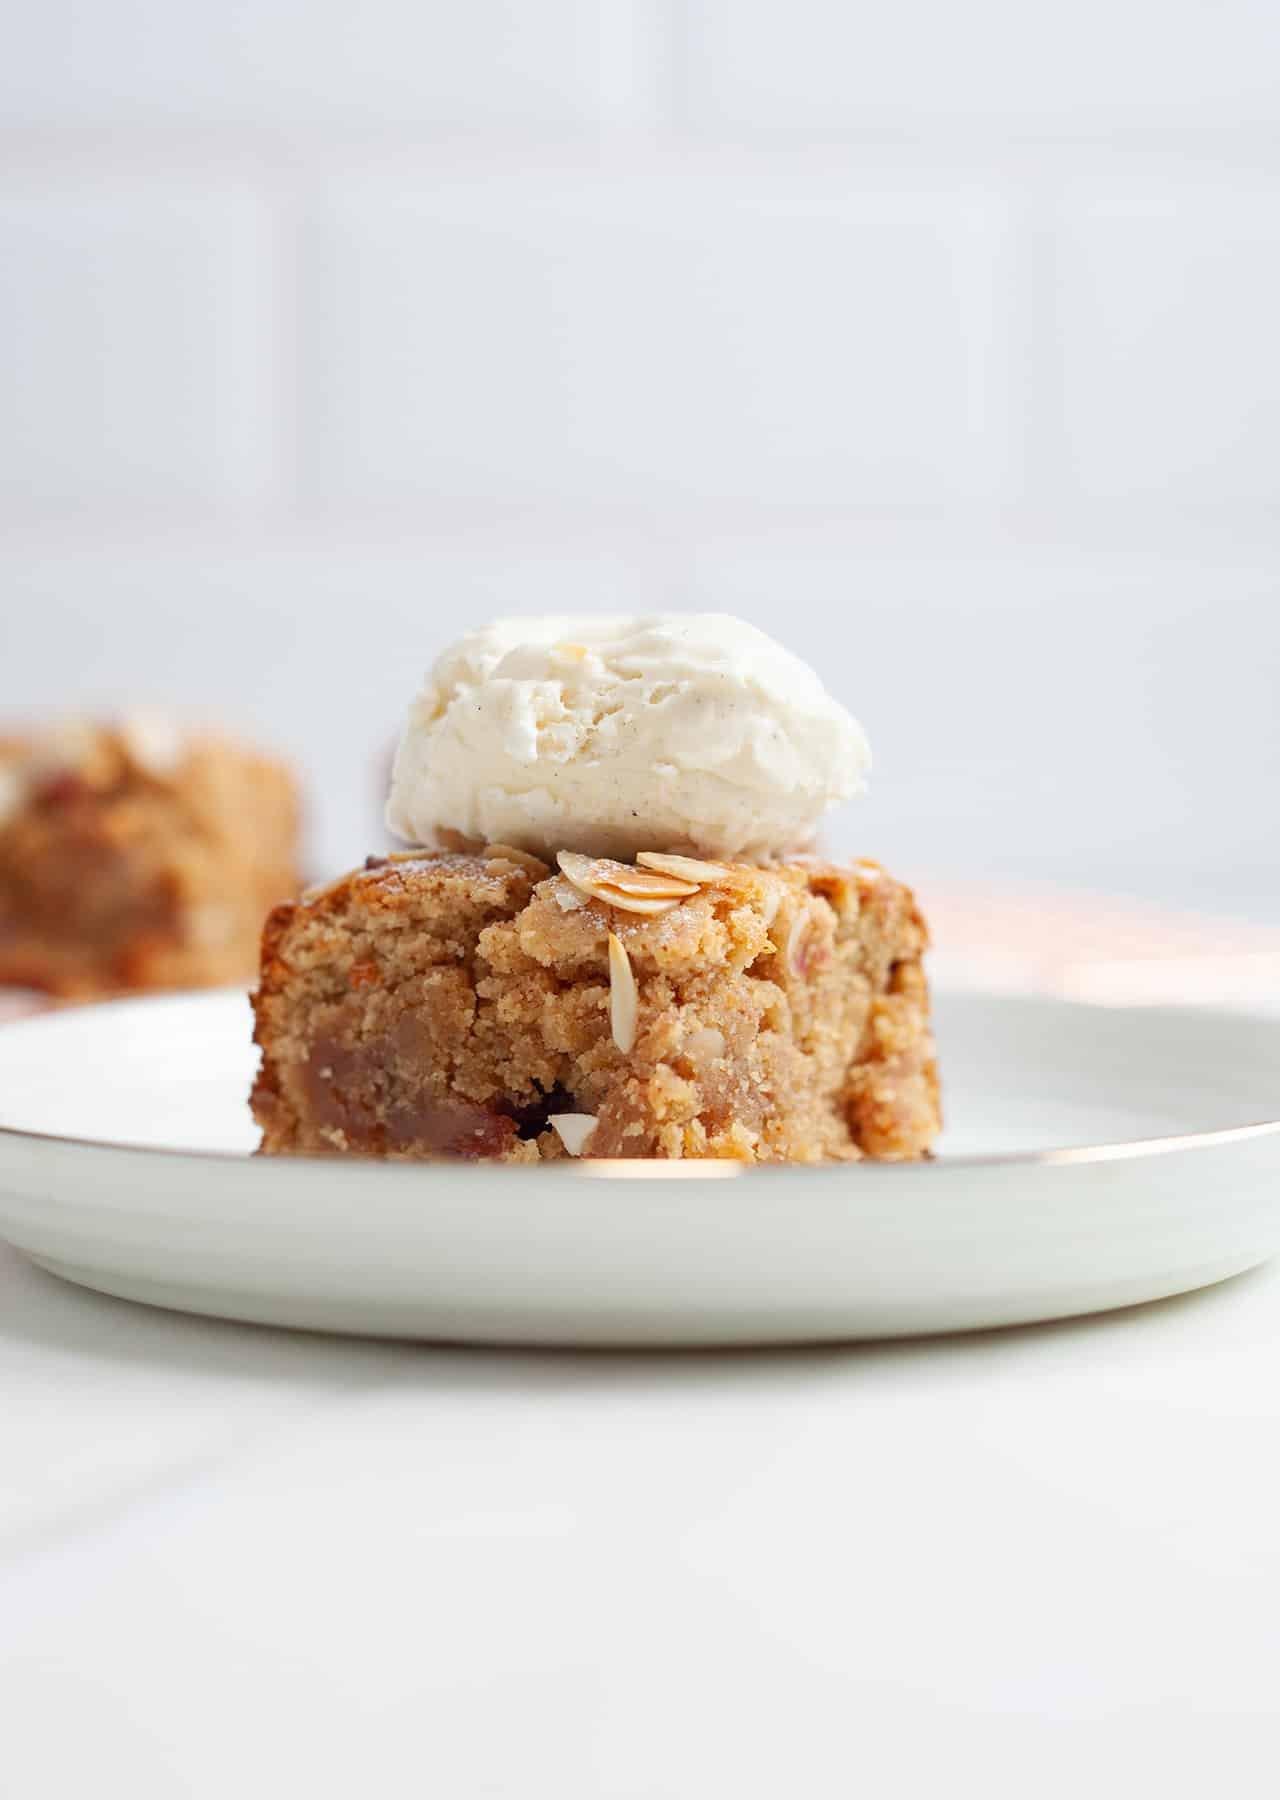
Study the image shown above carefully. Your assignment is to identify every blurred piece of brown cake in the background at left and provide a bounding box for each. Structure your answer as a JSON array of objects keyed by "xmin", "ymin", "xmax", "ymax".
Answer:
[{"xmin": 0, "ymin": 711, "xmax": 301, "ymax": 999}]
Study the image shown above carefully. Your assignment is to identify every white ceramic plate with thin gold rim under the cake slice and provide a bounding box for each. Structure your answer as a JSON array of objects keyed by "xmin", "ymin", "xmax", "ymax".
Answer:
[{"xmin": 0, "ymin": 994, "xmax": 1280, "ymax": 1345}]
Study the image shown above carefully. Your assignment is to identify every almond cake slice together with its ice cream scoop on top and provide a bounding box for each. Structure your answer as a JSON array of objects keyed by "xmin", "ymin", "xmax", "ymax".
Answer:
[{"xmin": 252, "ymin": 614, "xmax": 940, "ymax": 1163}]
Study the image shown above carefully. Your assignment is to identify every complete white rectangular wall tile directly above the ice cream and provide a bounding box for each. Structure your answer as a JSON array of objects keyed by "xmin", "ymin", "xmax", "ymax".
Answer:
[{"xmin": 304, "ymin": 158, "xmax": 1012, "ymax": 509}]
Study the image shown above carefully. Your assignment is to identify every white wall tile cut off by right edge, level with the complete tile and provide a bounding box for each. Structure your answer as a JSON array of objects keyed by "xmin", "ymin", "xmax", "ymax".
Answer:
[{"xmin": 1051, "ymin": 171, "xmax": 1280, "ymax": 506}]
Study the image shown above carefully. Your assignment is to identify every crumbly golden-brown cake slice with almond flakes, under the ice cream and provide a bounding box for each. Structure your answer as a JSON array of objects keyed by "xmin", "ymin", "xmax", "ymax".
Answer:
[{"xmin": 252, "ymin": 846, "xmax": 940, "ymax": 1163}]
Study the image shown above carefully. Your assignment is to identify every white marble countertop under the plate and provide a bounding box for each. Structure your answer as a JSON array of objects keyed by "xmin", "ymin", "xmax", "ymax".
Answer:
[{"xmin": 0, "ymin": 892, "xmax": 1280, "ymax": 1800}]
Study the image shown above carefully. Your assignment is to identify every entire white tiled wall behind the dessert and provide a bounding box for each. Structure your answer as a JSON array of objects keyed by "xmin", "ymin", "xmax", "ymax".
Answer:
[{"xmin": 0, "ymin": 0, "xmax": 1280, "ymax": 916}]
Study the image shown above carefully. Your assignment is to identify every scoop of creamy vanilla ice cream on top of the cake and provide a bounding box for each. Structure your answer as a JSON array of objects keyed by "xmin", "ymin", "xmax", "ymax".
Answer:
[{"xmin": 387, "ymin": 612, "xmax": 871, "ymax": 859}]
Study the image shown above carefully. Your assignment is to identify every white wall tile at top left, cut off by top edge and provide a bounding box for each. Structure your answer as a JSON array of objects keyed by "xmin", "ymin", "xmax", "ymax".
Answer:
[{"xmin": 0, "ymin": 0, "xmax": 650, "ymax": 126}]
